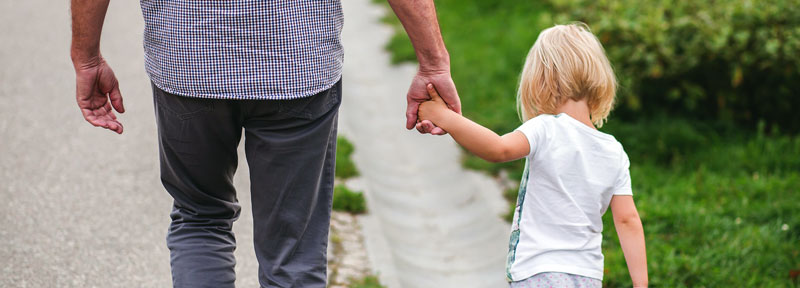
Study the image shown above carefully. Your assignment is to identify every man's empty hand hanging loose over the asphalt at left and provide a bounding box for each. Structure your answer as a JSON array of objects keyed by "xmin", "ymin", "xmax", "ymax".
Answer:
[{"xmin": 75, "ymin": 57, "xmax": 125, "ymax": 134}]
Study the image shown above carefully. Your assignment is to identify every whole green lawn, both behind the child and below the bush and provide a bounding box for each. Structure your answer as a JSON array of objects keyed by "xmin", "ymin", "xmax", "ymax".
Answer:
[{"xmin": 376, "ymin": 0, "xmax": 800, "ymax": 287}]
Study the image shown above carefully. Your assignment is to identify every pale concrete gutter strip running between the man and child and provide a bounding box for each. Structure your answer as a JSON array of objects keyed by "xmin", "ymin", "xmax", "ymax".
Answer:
[{"xmin": 339, "ymin": 0, "xmax": 509, "ymax": 288}]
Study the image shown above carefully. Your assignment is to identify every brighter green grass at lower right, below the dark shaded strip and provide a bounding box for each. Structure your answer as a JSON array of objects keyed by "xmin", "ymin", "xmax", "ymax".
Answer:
[{"xmin": 603, "ymin": 164, "xmax": 800, "ymax": 287}]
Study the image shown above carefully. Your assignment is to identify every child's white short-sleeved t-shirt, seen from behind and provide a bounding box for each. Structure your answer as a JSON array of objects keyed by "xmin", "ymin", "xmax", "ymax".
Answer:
[{"xmin": 506, "ymin": 113, "xmax": 633, "ymax": 281}]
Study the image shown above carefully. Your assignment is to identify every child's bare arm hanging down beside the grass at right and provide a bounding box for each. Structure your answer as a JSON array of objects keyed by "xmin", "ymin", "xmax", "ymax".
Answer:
[{"xmin": 611, "ymin": 195, "xmax": 647, "ymax": 287}]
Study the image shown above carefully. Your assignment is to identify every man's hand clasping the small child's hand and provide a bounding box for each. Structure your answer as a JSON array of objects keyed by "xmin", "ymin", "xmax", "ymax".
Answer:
[{"xmin": 406, "ymin": 71, "xmax": 461, "ymax": 135}]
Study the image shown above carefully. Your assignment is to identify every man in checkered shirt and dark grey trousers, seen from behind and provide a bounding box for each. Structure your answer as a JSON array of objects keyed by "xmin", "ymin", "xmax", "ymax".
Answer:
[{"xmin": 71, "ymin": 0, "xmax": 460, "ymax": 287}]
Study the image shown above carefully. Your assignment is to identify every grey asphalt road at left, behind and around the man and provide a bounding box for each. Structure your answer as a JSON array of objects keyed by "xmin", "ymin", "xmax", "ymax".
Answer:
[{"xmin": 0, "ymin": 0, "xmax": 258, "ymax": 287}]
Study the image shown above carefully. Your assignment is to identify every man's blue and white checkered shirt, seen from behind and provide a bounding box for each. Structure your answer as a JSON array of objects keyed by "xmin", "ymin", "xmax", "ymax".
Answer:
[{"xmin": 141, "ymin": 0, "xmax": 344, "ymax": 100}]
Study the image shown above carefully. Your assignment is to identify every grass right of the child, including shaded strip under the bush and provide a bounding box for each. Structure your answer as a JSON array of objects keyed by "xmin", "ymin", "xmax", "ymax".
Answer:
[{"xmin": 505, "ymin": 120, "xmax": 800, "ymax": 287}]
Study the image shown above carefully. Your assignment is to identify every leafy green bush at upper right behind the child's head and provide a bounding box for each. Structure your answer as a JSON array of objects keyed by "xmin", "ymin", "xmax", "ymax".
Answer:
[{"xmin": 547, "ymin": 0, "xmax": 800, "ymax": 132}]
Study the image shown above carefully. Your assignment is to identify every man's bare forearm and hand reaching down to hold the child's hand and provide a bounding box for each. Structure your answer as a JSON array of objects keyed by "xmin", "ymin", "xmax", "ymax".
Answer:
[{"xmin": 389, "ymin": 0, "xmax": 461, "ymax": 135}]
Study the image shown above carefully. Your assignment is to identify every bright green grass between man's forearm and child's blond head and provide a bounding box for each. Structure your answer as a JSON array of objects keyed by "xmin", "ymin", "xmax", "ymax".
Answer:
[{"xmin": 384, "ymin": 0, "xmax": 552, "ymax": 131}]
